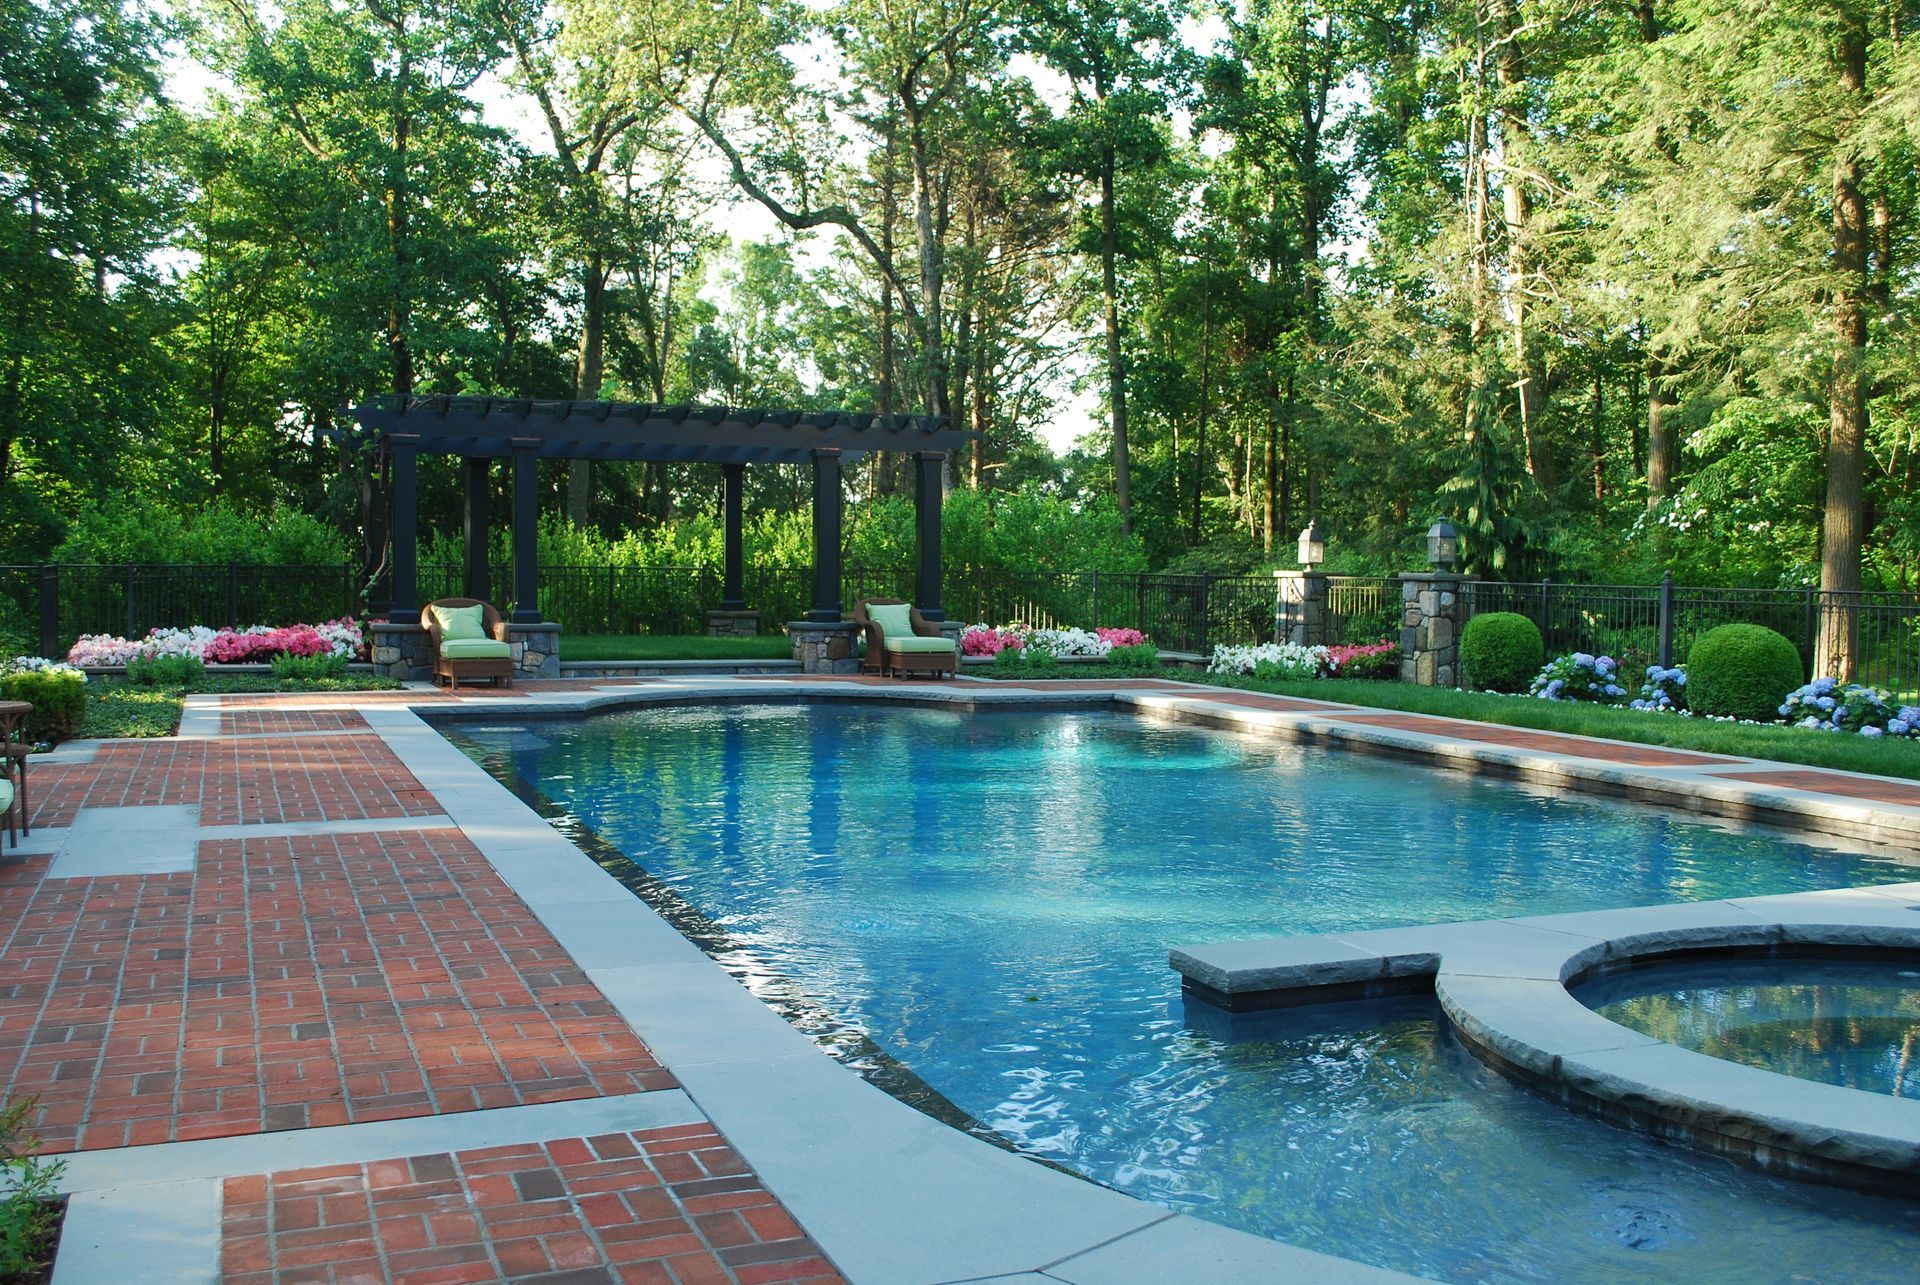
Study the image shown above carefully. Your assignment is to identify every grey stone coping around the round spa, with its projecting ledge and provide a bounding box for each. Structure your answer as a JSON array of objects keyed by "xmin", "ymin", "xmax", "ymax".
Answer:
[{"xmin": 1167, "ymin": 882, "xmax": 1920, "ymax": 1197}]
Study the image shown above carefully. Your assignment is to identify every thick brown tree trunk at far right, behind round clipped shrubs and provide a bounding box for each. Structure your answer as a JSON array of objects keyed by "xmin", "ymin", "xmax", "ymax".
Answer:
[{"xmin": 1814, "ymin": 13, "xmax": 1870, "ymax": 682}]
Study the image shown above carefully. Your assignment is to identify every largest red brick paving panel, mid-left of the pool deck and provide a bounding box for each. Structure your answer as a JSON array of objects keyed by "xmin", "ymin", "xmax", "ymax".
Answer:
[{"xmin": 0, "ymin": 830, "xmax": 674, "ymax": 1151}]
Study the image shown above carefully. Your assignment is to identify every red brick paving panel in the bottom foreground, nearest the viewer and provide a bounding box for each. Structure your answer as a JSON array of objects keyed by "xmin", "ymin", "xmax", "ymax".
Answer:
[{"xmin": 221, "ymin": 1124, "xmax": 841, "ymax": 1285}]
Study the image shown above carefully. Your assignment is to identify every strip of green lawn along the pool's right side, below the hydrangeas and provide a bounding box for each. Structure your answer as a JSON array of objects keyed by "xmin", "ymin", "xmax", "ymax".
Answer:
[{"xmin": 1179, "ymin": 670, "xmax": 1920, "ymax": 780}]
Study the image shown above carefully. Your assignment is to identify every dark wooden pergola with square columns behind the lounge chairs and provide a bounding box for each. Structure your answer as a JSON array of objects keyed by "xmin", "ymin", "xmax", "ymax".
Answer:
[{"xmin": 353, "ymin": 396, "xmax": 975, "ymax": 624}]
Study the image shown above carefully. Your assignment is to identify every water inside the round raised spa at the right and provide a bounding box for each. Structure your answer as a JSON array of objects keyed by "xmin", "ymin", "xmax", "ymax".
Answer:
[{"xmin": 1574, "ymin": 958, "xmax": 1920, "ymax": 1097}]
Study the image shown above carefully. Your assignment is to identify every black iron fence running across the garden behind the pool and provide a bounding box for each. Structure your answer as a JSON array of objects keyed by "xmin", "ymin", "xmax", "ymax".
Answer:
[{"xmin": 0, "ymin": 563, "xmax": 1920, "ymax": 691}]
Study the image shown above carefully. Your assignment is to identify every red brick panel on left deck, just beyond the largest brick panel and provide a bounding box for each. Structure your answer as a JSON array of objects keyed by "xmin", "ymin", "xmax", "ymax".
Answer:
[{"xmin": 33, "ymin": 736, "xmax": 440, "ymax": 826}]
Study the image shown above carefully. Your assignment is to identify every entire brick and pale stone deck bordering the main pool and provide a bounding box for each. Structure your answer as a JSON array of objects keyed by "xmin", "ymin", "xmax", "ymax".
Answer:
[{"xmin": 11, "ymin": 676, "xmax": 1920, "ymax": 1281}]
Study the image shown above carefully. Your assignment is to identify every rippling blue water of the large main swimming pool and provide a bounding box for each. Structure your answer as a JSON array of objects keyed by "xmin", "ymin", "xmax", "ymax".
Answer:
[{"xmin": 451, "ymin": 705, "xmax": 1920, "ymax": 1281}]
